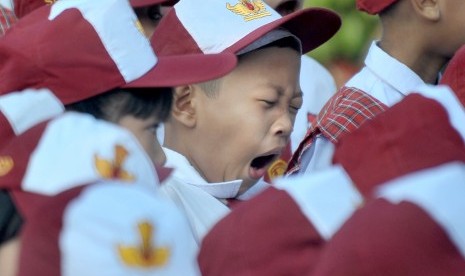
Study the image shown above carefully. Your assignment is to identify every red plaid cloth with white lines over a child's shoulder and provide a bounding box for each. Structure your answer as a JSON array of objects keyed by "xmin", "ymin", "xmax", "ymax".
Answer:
[{"xmin": 286, "ymin": 87, "xmax": 388, "ymax": 175}]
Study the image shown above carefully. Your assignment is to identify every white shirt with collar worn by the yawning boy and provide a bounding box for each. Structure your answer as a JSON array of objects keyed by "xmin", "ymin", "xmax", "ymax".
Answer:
[{"xmin": 161, "ymin": 148, "xmax": 269, "ymax": 245}]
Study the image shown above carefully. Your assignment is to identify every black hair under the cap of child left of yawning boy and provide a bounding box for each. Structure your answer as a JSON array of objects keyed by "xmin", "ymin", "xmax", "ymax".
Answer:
[{"xmin": 66, "ymin": 88, "xmax": 173, "ymax": 123}]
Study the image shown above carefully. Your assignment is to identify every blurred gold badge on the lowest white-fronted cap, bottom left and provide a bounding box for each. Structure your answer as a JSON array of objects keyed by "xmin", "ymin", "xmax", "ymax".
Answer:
[{"xmin": 118, "ymin": 222, "xmax": 170, "ymax": 268}]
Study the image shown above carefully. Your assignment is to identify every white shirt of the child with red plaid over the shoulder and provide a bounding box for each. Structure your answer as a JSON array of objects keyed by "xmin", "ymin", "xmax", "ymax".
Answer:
[{"xmin": 298, "ymin": 41, "xmax": 425, "ymax": 174}]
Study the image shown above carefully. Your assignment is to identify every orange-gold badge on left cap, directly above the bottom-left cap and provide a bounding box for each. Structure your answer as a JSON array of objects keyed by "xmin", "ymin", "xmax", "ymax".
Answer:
[{"xmin": 94, "ymin": 145, "xmax": 135, "ymax": 181}]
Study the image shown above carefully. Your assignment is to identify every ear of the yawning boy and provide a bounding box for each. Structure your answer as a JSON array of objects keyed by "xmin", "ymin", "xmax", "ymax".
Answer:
[{"xmin": 171, "ymin": 85, "xmax": 196, "ymax": 128}]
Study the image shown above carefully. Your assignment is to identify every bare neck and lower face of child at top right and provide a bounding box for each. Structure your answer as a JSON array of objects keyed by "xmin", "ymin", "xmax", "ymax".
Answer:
[{"xmin": 379, "ymin": 0, "xmax": 465, "ymax": 83}]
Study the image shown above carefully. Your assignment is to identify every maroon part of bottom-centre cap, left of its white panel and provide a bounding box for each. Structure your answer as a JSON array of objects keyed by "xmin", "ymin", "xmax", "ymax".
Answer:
[{"xmin": 198, "ymin": 187, "xmax": 325, "ymax": 276}]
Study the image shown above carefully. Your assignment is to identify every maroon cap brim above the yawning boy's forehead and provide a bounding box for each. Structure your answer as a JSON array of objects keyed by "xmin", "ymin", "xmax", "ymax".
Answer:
[{"xmin": 227, "ymin": 8, "xmax": 341, "ymax": 53}]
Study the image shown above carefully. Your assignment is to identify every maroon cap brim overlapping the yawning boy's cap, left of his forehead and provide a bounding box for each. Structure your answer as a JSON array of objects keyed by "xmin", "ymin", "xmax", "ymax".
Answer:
[{"xmin": 124, "ymin": 53, "xmax": 237, "ymax": 88}]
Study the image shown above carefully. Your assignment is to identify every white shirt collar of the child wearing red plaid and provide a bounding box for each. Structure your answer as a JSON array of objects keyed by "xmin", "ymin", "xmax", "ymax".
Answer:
[{"xmin": 365, "ymin": 41, "xmax": 425, "ymax": 96}]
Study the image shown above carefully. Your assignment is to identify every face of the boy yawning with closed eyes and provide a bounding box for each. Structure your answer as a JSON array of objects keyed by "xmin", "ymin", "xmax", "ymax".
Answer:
[{"xmin": 190, "ymin": 47, "xmax": 302, "ymax": 191}]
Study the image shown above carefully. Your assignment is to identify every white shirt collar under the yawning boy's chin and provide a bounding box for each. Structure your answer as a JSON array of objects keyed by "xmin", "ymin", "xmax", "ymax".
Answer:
[{"xmin": 163, "ymin": 148, "xmax": 268, "ymax": 200}]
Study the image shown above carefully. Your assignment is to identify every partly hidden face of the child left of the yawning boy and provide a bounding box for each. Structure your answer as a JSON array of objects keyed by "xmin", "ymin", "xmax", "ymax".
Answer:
[{"xmin": 118, "ymin": 115, "xmax": 166, "ymax": 166}]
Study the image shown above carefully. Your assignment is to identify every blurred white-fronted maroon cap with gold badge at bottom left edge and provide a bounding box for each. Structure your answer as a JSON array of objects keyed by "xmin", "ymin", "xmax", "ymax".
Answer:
[{"xmin": 18, "ymin": 182, "xmax": 199, "ymax": 276}]
